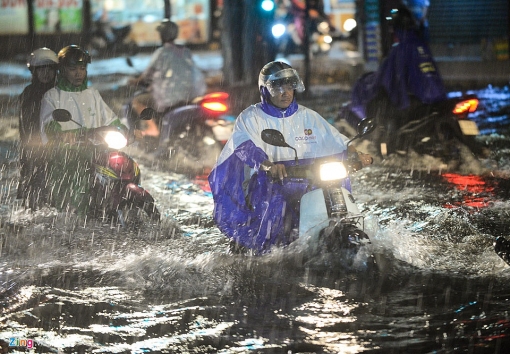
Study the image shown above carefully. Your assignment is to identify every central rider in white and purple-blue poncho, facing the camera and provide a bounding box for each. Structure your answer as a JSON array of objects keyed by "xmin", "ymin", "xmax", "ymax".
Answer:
[{"xmin": 208, "ymin": 61, "xmax": 372, "ymax": 253}]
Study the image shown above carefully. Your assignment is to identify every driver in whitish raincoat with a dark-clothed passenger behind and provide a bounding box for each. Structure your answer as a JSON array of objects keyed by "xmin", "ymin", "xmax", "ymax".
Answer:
[{"xmin": 40, "ymin": 45, "xmax": 127, "ymax": 211}]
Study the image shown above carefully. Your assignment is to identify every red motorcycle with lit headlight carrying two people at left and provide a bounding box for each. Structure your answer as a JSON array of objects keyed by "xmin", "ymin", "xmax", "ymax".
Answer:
[{"xmin": 52, "ymin": 109, "xmax": 160, "ymax": 227}]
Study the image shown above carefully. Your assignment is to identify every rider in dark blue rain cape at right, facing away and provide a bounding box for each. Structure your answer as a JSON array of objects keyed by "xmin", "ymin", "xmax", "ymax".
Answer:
[{"xmin": 351, "ymin": 6, "xmax": 446, "ymax": 150}]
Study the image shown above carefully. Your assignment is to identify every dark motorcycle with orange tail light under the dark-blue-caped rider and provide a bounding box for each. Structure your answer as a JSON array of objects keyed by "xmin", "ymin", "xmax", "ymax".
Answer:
[{"xmin": 337, "ymin": 81, "xmax": 483, "ymax": 161}]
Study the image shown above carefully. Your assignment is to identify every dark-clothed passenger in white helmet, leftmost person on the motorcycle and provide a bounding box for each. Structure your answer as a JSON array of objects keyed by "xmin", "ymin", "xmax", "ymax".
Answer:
[{"xmin": 17, "ymin": 47, "xmax": 58, "ymax": 209}]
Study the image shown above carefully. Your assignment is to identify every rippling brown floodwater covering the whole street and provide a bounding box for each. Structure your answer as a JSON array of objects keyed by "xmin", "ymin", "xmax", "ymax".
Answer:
[{"xmin": 0, "ymin": 84, "xmax": 510, "ymax": 353}]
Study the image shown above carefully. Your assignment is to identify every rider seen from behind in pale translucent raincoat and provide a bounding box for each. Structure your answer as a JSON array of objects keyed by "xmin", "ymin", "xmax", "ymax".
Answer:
[{"xmin": 128, "ymin": 19, "xmax": 206, "ymax": 136}]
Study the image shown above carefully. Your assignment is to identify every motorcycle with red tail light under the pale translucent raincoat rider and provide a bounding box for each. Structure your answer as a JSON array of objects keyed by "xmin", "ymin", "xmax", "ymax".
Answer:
[{"xmin": 123, "ymin": 58, "xmax": 235, "ymax": 176}]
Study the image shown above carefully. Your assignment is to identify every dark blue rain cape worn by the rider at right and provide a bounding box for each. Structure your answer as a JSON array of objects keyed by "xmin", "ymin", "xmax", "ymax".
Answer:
[{"xmin": 351, "ymin": 27, "xmax": 446, "ymax": 119}]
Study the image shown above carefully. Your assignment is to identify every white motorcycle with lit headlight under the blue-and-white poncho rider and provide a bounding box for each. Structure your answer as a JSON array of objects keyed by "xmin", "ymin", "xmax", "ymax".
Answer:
[{"xmin": 261, "ymin": 119, "xmax": 375, "ymax": 266}]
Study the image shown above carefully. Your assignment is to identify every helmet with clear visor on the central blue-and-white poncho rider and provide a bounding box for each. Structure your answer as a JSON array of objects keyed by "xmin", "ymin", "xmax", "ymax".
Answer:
[{"xmin": 259, "ymin": 61, "xmax": 305, "ymax": 97}]
